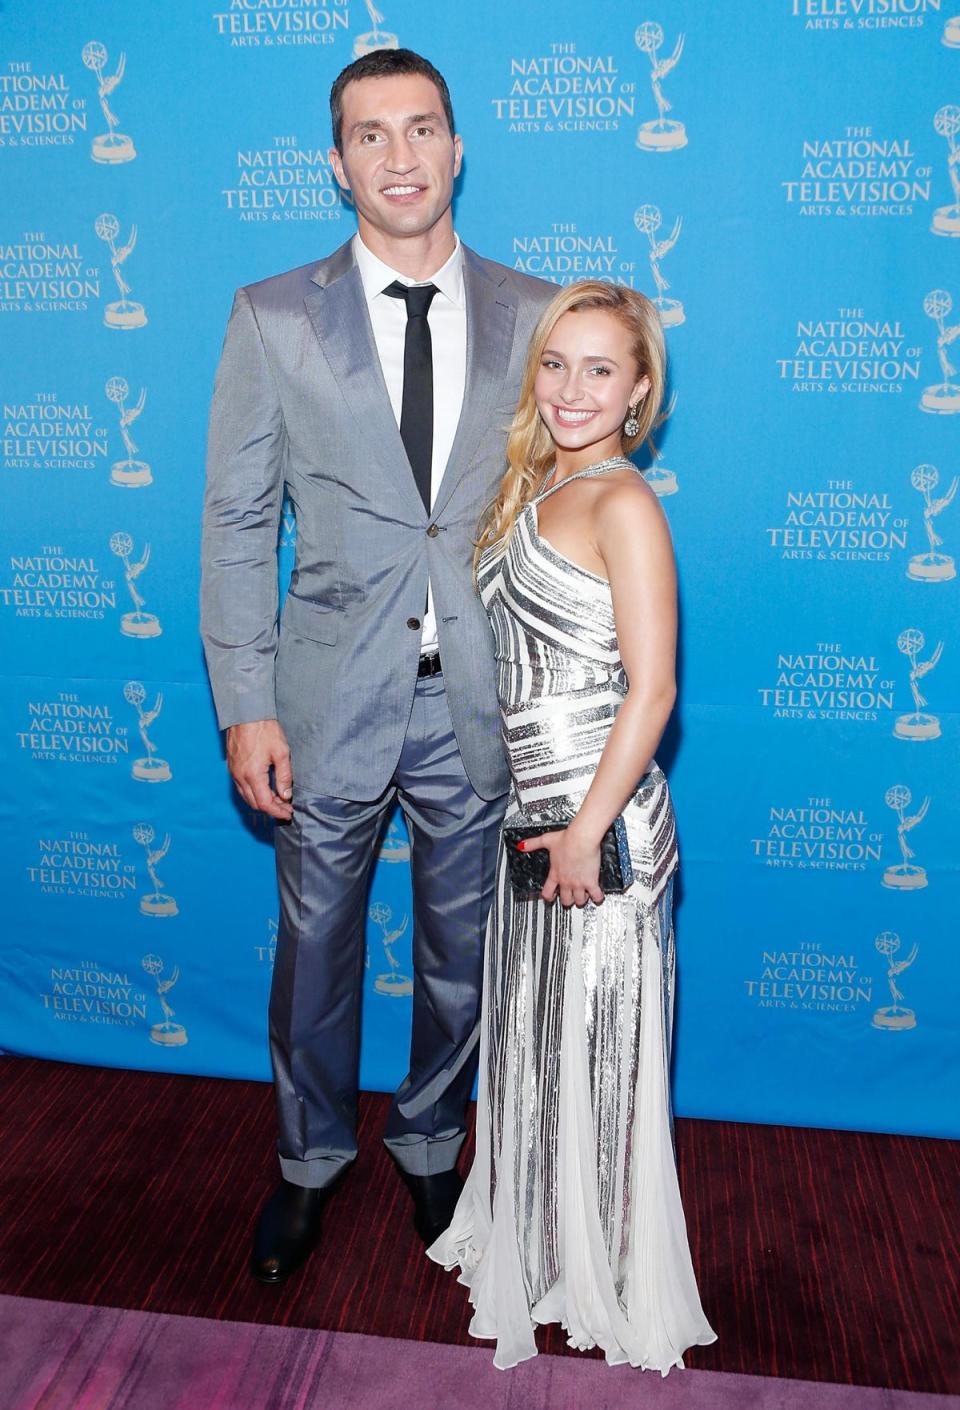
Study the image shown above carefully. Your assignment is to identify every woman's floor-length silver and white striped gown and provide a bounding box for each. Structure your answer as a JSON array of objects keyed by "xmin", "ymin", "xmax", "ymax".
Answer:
[{"xmin": 429, "ymin": 458, "xmax": 715, "ymax": 1375}]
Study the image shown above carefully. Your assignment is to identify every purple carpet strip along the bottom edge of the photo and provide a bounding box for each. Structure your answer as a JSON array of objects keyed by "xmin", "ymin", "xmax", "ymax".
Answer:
[{"xmin": 0, "ymin": 1294, "xmax": 960, "ymax": 1410}]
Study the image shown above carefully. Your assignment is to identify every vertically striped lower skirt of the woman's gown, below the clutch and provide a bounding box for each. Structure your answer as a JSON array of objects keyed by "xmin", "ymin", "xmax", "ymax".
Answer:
[{"xmin": 429, "ymin": 840, "xmax": 716, "ymax": 1376}]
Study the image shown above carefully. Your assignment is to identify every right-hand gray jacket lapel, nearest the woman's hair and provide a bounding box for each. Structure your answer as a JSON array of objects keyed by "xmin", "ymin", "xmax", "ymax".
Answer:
[{"xmin": 433, "ymin": 245, "xmax": 517, "ymax": 517}]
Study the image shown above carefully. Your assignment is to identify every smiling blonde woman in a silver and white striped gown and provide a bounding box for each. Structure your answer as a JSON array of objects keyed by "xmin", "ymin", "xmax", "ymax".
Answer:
[{"xmin": 429, "ymin": 281, "xmax": 715, "ymax": 1375}]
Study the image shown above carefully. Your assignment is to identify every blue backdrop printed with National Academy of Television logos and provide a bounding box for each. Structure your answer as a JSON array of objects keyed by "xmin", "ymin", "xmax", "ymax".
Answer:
[{"xmin": 0, "ymin": 0, "xmax": 960, "ymax": 1135}]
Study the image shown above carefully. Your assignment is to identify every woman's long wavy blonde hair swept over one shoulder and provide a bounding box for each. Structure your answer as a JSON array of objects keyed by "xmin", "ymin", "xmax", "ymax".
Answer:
[{"xmin": 474, "ymin": 279, "xmax": 667, "ymax": 563}]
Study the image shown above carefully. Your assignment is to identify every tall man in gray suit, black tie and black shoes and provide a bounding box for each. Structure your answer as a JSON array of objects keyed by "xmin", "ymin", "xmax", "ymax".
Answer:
[{"xmin": 202, "ymin": 49, "xmax": 554, "ymax": 1283}]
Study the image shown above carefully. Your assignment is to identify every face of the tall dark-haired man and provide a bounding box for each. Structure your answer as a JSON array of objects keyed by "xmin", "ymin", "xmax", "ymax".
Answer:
[{"xmin": 330, "ymin": 73, "xmax": 462, "ymax": 238}]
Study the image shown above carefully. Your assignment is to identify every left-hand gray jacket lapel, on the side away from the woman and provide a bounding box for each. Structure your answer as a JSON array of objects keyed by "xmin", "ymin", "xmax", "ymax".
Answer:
[{"xmin": 303, "ymin": 243, "xmax": 423, "ymax": 516}]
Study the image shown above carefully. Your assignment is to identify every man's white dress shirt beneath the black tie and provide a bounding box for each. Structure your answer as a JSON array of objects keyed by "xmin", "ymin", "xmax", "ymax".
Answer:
[{"xmin": 354, "ymin": 235, "xmax": 467, "ymax": 654}]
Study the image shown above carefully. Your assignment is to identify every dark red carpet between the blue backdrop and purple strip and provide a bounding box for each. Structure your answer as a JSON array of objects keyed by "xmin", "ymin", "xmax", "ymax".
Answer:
[{"xmin": 0, "ymin": 1058, "xmax": 960, "ymax": 1393}]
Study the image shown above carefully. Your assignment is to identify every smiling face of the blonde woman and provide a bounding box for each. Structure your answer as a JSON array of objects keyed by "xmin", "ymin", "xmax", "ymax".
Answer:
[{"xmin": 533, "ymin": 309, "xmax": 650, "ymax": 457}]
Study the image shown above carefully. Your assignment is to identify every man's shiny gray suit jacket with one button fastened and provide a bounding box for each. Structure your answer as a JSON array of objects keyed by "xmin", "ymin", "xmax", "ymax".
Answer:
[{"xmin": 200, "ymin": 243, "xmax": 555, "ymax": 799}]
